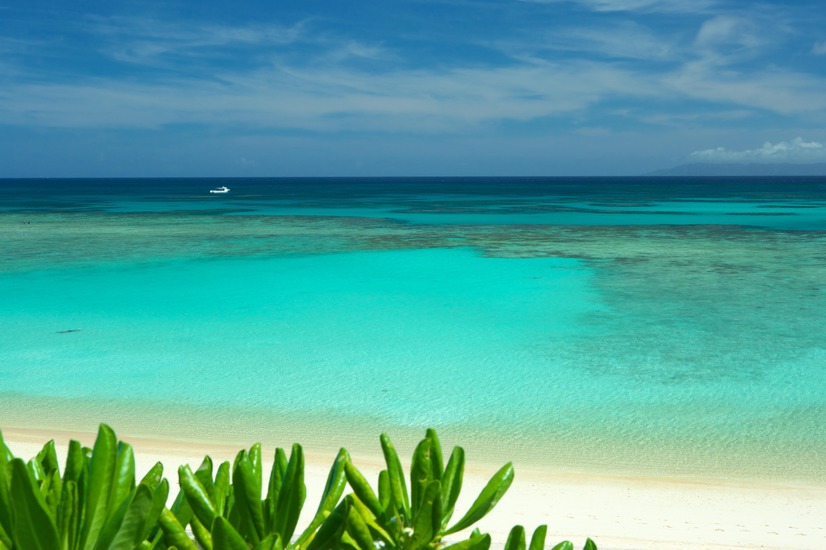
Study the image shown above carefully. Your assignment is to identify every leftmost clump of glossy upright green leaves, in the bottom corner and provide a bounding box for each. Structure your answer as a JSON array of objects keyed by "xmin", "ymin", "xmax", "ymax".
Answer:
[{"xmin": 0, "ymin": 424, "xmax": 169, "ymax": 550}]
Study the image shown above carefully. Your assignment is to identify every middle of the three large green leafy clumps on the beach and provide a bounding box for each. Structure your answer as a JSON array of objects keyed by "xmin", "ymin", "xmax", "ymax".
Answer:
[{"xmin": 161, "ymin": 444, "xmax": 349, "ymax": 550}]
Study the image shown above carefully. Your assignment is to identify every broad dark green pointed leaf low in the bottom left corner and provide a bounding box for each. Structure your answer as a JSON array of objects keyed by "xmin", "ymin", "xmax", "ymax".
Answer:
[{"xmin": 10, "ymin": 458, "xmax": 59, "ymax": 550}]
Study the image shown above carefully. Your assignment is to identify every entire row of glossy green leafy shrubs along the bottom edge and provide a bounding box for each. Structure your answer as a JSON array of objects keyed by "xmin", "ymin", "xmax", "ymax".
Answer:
[{"xmin": 0, "ymin": 424, "xmax": 597, "ymax": 550}]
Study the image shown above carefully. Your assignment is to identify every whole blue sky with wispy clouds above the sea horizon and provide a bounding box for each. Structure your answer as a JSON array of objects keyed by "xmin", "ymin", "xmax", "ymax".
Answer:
[{"xmin": 0, "ymin": 0, "xmax": 826, "ymax": 178}]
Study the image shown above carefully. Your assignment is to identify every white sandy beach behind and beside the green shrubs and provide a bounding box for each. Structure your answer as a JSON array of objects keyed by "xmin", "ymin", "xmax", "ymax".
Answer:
[{"xmin": 3, "ymin": 428, "xmax": 826, "ymax": 550}]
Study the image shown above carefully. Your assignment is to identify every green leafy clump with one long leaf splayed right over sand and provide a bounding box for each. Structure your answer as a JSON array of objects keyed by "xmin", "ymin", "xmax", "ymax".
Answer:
[{"xmin": 344, "ymin": 429, "xmax": 514, "ymax": 550}]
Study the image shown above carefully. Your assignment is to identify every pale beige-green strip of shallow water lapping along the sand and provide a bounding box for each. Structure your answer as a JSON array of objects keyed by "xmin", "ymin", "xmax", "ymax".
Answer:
[{"xmin": 0, "ymin": 392, "xmax": 826, "ymax": 487}]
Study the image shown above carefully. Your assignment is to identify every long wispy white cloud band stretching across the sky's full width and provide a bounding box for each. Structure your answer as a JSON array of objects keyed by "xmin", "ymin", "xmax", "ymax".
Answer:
[{"xmin": 0, "ymin": 37, "xmax": 826, "ymax": 139}]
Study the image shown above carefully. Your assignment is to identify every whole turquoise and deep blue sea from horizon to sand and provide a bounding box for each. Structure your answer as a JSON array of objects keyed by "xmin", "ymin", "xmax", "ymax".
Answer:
[{"xmin": 0, "ymin": 178, "xmax": 826, "ymax": 482}]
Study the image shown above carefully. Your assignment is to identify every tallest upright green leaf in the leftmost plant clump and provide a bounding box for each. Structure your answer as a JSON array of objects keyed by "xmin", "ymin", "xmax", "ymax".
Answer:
[{"xmin": 80, "ymin": 424, "xmax": 117, "ymax": 550}]
